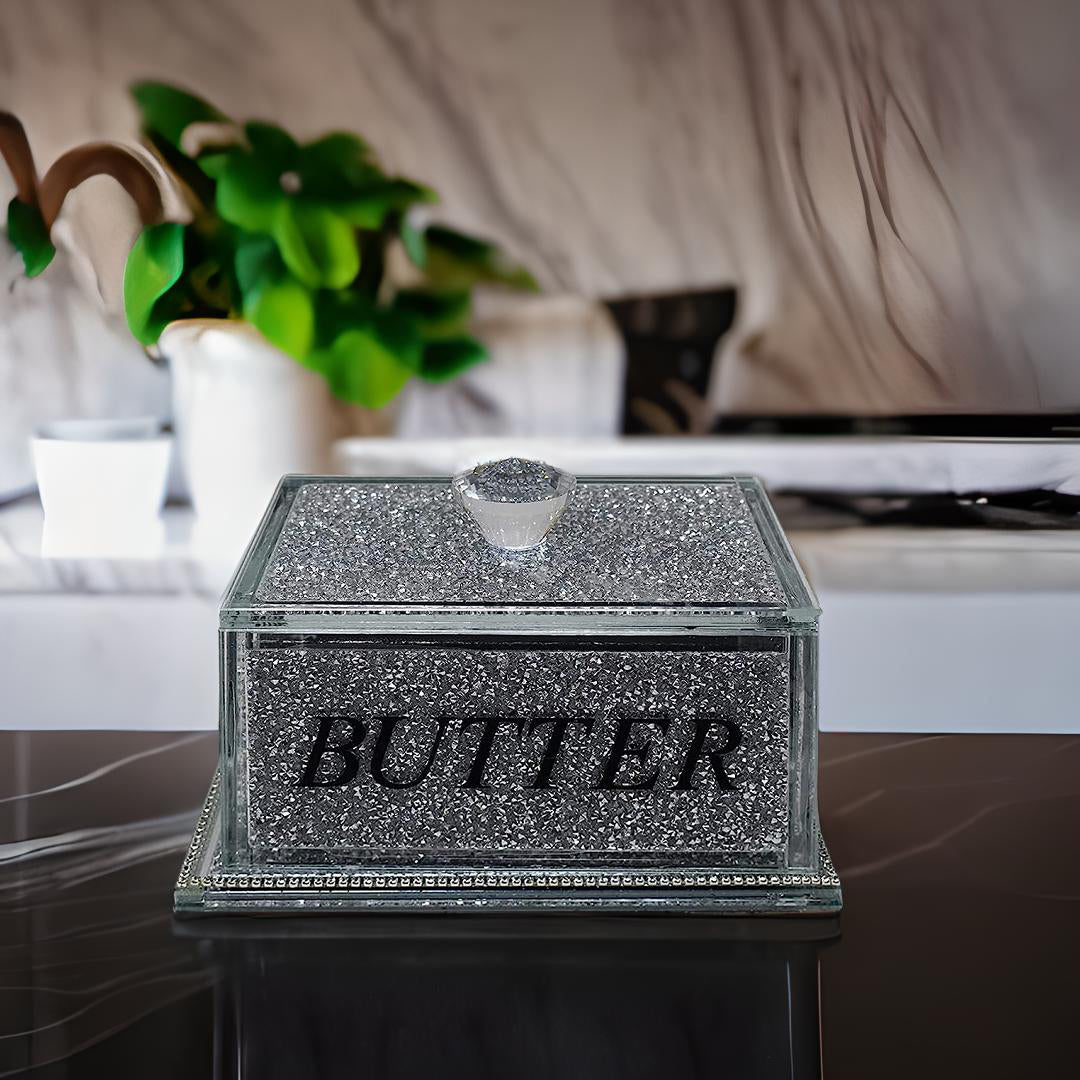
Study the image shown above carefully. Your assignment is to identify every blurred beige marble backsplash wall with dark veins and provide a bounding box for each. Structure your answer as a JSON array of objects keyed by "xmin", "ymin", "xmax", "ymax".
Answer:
[{"xmin": 0, "ymin": 0, "xmax": 1080, "ymax": 477}]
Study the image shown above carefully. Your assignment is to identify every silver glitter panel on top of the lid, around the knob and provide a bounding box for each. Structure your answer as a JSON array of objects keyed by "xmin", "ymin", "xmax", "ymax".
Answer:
[{"xmin": 256, "ymin": 481, "xmax": 785, "ymax": 606}]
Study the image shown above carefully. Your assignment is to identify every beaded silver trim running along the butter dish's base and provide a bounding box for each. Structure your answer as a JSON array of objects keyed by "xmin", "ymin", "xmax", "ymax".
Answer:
[{"xmin": 176, "ymin": 773, "xmax": 840, "ymax": 907}]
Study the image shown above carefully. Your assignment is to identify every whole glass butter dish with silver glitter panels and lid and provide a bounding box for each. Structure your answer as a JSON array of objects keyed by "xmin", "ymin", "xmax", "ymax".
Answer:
[{"xmin": 175, "ymin": 459, "xmax": 840, "ymax": 914}]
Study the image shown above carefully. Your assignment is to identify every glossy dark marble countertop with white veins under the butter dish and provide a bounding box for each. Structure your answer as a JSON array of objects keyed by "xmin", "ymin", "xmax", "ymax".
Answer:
[{"xmin": 0, "ymin": 732, "xmax": 1080, "ymax": 1080}]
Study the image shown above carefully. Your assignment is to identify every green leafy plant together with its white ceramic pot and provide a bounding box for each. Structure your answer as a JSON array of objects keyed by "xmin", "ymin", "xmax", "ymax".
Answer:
[{"xmin": 124, "ymin": 82, "xmax": 536, "ymax": 540}]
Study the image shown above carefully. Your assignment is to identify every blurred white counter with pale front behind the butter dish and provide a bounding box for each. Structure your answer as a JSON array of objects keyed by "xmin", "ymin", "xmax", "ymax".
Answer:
[{"xmin": 0, "ymin": 499, "xmax": 1080, "ymax": 732}]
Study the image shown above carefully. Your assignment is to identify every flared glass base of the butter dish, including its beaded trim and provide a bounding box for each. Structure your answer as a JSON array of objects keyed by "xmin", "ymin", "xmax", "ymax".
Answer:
[{"xmin": 174, "ymin": 774, "xmax": 841, "ymax": 915}]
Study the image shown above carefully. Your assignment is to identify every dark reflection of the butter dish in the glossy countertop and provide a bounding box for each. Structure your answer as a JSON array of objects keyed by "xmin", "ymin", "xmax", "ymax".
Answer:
[{"xmin": 190, "ymin": 913, "xmax": 839, "ymax": 1080}]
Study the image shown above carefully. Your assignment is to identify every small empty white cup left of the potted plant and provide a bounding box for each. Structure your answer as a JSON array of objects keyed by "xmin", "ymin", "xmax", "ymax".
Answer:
[{"xmin": 30, "ymin": 418, "xmax": 172, "ymax": 557}]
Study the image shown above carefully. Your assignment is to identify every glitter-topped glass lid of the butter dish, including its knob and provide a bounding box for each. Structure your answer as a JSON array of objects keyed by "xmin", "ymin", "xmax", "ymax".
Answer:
[{"xmin": 222, "ymin": 459, "xmax": 816, "ymax": 625}]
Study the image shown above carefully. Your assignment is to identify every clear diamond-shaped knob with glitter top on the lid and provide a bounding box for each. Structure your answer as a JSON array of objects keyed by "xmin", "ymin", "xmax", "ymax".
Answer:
[{"xmin": 451, "ymin": 458, "xmax": 576, "ymax": 551}]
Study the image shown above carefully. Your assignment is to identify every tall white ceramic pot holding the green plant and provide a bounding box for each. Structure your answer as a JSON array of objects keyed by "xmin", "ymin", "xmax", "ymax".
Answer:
[{"xmin": 159, "ymin": 319, "xmax": 340, "ymax": 555}]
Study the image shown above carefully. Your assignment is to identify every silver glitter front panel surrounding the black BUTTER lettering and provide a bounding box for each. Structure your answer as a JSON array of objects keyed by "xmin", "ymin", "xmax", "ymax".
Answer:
[{"xmin": 241, "ymin": 643, "xmax": 791, "ymax": 866}]
